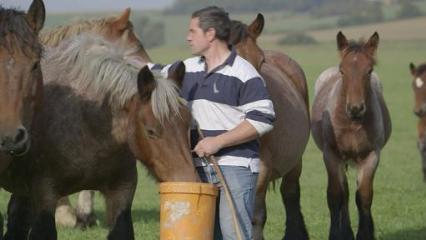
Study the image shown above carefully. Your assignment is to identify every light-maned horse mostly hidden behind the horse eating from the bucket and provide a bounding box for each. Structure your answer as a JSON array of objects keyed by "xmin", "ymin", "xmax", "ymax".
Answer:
[{"xmin": 36, "ymin": 8, "xmax": 150, "ymax": 228}]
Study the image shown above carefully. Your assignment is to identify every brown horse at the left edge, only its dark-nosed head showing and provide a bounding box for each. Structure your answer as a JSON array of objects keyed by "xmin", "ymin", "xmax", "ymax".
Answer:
[{"xmin": 0, "ymin": 0, "xmax": 45, "ymax": 236}]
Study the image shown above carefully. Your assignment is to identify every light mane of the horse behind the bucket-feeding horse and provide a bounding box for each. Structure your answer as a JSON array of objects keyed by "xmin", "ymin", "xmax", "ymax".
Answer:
[{"xmin": 40, "ymin": 17, "xmax": 115, "ymax": 47}]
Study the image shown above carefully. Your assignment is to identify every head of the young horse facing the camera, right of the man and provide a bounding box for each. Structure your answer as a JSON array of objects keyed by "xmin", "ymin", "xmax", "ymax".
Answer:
[{"xmin": 337, "ymin": 32, "xmax": 379, "ymax": 120}]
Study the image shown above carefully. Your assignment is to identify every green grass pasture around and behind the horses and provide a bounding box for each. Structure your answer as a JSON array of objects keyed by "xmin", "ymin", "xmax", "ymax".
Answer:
[{"xmin": 0, "ymin": 7, "xmax": 426, "ymax": 240}]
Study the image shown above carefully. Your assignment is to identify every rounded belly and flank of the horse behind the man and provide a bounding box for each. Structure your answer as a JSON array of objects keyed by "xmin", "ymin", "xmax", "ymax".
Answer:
[{"xmin": 261, "ymin": 64, "xmax": 310, "ymax": 177}]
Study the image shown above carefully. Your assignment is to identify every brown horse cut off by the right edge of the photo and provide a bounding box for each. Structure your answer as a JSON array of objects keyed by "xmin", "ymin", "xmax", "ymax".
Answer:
[{"xmin": 410, "ymin": 63, "xmax": 426, "ymax": 181}]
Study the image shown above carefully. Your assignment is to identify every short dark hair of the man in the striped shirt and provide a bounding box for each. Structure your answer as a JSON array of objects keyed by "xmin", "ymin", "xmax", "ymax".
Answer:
[{"xmin": 192, "ymin": 6, "xmax": 231, "ymax": 42}]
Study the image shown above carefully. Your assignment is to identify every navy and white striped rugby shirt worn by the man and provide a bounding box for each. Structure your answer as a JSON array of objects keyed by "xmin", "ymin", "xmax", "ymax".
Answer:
[{"xmin": 150, "ymin": 49, "xmax": 275, "ymax": 172}]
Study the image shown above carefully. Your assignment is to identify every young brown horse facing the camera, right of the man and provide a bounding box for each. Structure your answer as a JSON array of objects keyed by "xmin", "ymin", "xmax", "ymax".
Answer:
[{"xmin": 312, "ymin": 32, "xmax": 391, "ymax": 239}]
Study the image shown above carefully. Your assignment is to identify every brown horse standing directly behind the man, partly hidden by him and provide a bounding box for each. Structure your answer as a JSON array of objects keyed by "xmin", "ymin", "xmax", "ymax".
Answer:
[{"xmin": 229, "ymin": 14, "xmax": 310, "ymax": 239}]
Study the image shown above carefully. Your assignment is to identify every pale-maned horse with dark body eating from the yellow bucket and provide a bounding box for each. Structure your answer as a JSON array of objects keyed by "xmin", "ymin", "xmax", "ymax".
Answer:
[{"xmin": 1, "ymin": 35, "xmax": 195, "ymax": 239}]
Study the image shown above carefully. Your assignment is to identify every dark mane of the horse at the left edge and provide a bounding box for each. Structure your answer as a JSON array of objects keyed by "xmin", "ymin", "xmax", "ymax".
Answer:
[{"xmin": 0, "ymin": 6, "xmax": 43, "ymax": 56}]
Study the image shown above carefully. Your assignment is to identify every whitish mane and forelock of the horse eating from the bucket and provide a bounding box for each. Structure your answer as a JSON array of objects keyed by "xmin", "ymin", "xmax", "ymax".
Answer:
[{"xmin": 46, "ymin": 34, "xmax": 183, "ymax": 123}]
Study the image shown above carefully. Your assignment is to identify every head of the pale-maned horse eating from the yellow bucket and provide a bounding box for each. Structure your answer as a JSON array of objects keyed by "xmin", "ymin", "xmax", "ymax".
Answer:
[{"xmin": 129, "ymin": 62, "xmax": 198, "ymax": 181}]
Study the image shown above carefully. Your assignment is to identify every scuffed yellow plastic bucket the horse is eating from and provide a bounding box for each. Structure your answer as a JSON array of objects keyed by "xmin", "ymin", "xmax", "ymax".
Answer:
[{"xmin": 160, "ymin": 182, "xmax": 218, "ymax": 240}]
